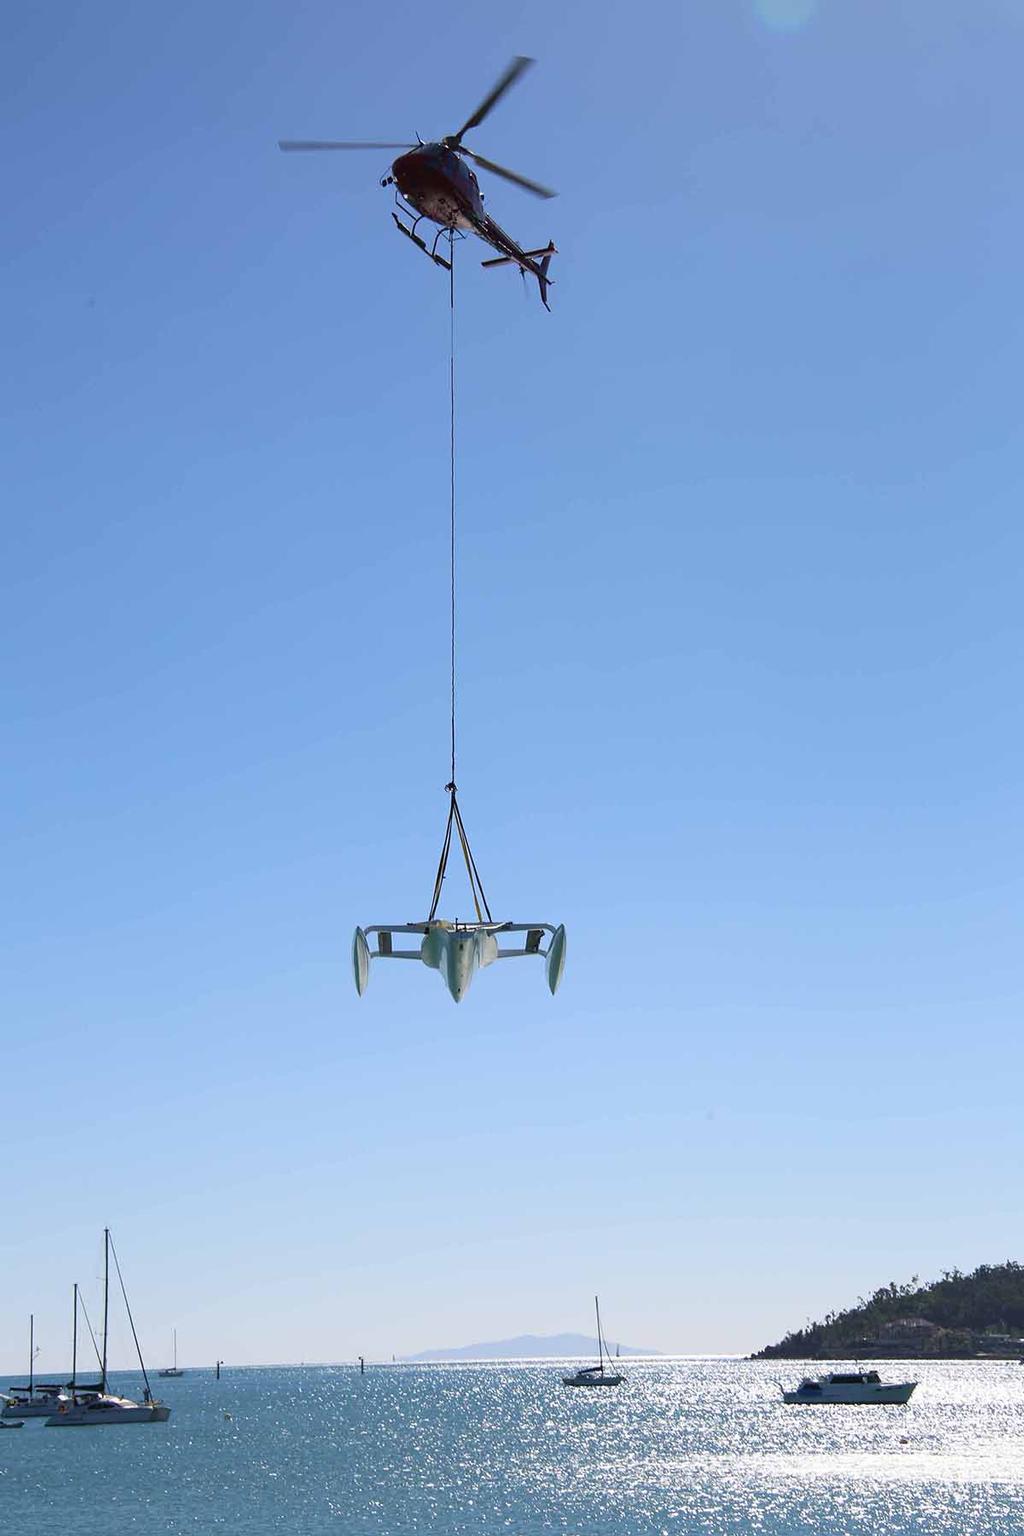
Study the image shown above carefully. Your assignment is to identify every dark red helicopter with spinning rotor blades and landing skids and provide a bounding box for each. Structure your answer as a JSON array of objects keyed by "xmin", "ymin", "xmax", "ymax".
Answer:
[{"xmin": 278, "ymin": 55, "xmax": 557, "ymax": 309}]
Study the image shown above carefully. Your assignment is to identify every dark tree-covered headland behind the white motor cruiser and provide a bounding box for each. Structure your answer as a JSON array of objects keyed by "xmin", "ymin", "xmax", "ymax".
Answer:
[{"xmin": 754, "ymin": 1261, "xmax": 1024, "ymax": 1359}]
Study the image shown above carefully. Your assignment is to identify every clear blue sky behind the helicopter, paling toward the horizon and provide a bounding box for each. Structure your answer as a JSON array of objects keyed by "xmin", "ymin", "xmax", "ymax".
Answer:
[{"xmin": 0, "ymin": 0, "xmax": 1024, "ymax": 1370}]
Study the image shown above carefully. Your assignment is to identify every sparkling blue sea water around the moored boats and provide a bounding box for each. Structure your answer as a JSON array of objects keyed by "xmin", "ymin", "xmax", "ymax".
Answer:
[{"xmin": 0, "ymin": 1359, "xmax": 1024, "ymax": 1536}]
